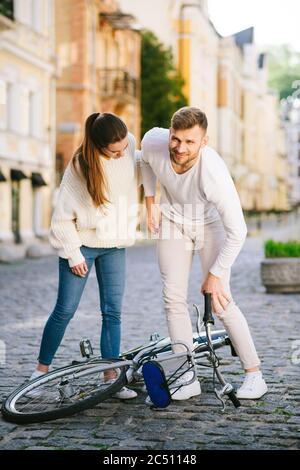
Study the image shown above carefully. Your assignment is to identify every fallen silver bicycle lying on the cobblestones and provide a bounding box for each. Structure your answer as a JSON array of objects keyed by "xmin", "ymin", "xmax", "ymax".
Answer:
[{"xmin": 1, "ymin": 294, "xmax": 240, "ymax": 424}]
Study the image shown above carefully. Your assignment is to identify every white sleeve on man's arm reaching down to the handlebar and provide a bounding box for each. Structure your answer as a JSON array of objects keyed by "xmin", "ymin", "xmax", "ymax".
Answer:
[{"xmin": 202, "ymin": 154, "xmax": 247, "ymax": 277}]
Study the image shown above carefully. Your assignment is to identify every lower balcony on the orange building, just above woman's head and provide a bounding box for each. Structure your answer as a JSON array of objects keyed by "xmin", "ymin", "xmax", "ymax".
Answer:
[{"xmin": 98, "ymin": 69, "xmax": 139, "ymax": 104}]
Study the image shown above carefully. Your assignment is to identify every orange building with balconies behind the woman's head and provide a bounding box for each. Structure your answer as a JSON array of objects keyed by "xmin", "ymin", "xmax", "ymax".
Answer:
[{"xmin": 55, "ymin": 0, "xmax": 141, "ymax": 176}]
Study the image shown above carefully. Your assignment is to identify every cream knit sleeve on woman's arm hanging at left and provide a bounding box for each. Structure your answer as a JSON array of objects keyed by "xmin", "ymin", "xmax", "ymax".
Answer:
[{"xmin": 49, "ymin": 168, "xmax": 84, "ymax": 267}]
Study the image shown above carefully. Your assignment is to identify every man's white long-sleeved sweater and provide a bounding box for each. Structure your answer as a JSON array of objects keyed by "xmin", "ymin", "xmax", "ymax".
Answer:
[{"xmin": 141, "ymin": 127, "xmax": 247, "ymax": 277}]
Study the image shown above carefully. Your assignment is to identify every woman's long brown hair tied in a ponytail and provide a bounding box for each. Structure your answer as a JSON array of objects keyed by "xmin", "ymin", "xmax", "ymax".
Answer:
[{"xmin": 72, "ymin": 113, "xmax": 128, "ymax": 207}]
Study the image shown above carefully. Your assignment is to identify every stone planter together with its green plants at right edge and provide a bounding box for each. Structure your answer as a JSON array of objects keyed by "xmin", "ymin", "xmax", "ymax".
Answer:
[{"xmin": 261, "ymin": 240, "xmax": 300, "ymax": 294}]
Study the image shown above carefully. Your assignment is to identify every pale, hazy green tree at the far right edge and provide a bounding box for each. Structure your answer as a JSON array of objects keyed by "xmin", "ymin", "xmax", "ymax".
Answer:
[{"xmin": 268, "ymin": 45, "xmax": 300, "ymax": 99}]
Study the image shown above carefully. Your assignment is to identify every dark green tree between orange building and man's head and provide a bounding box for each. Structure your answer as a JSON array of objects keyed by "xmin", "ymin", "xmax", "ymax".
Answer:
[{"xmin": 141, "ymin": 31, "xmax": 188, "ymax": 135}]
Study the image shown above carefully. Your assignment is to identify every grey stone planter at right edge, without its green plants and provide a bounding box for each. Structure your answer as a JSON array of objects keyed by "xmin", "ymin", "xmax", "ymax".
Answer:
[{"xmin": 261, "ymin": 258, "xmax": 300, "ymax": 294}]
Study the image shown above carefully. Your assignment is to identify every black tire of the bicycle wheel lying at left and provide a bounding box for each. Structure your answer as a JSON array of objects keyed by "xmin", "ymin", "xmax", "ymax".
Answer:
[{"xmin": 1, "ymin": 359, "xmax": 128, "ymax": 424}]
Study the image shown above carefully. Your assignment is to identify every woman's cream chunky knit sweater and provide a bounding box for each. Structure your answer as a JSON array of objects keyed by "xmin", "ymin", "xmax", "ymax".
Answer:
[{"xmin": 49, "ymin": 134, "xmax": 138, "ymax": 267}]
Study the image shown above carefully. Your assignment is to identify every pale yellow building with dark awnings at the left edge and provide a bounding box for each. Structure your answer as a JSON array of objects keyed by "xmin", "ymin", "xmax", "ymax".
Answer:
[{"xmin": 0, "ymin": 0, "xmax": 55, "ymax": 253}]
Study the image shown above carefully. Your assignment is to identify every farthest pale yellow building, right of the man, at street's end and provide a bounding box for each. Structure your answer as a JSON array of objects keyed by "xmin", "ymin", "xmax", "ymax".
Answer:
[{"xmin": 237, "ymin": 42, "xmax": 289, "ymax": 211}]
